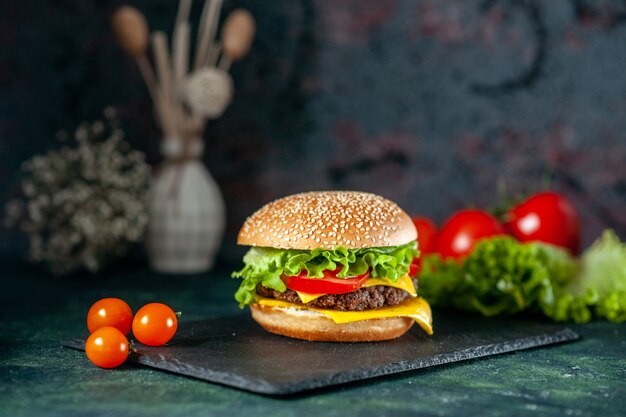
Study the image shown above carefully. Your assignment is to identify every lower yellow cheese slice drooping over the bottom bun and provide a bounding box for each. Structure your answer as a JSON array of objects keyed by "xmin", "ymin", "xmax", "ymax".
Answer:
[{"xmin": 256, "ymin": 295, "xmax": 433, "ymax": 335}]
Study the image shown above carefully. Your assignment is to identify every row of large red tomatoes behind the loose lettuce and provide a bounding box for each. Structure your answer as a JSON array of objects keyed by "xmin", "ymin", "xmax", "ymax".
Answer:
[{"xmin": 413, "ymin": 191, "xmax": 580, "ymax": 262}]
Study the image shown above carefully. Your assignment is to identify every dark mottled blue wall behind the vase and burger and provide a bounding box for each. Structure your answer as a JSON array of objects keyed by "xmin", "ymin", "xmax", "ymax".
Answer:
[{"xmin": 0, "ymin": 0, "xmax": 626, "ymax": 258}]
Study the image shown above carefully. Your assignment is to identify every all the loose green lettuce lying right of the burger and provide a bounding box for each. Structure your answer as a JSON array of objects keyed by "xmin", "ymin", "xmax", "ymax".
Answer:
[{"xmin": 419, "ymin": 231, "xmax": 626, "ymax": 323}]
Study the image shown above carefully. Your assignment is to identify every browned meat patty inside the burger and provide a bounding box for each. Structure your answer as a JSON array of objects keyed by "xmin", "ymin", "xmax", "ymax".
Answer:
[{"xmin": 256, "ymin": 278, "xmax": 417, "ymax": 311}]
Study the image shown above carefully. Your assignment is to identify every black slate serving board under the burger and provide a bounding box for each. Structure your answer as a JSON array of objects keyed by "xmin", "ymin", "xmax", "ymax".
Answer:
[{"xmin": 63, "ymin": 311, "xmax": 578, "ymax": 395}]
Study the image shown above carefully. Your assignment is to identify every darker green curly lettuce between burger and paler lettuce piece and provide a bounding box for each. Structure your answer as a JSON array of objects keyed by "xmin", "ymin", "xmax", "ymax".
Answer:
[{"xmin": 419, "ymin": 237, "xmax": 576, "ymax": 316}]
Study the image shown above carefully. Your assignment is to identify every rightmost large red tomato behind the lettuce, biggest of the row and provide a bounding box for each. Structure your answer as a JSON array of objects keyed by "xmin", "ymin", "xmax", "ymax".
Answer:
[{"xmin": 504, "ymin": 191, "xmax": 580, "ymax": 255}]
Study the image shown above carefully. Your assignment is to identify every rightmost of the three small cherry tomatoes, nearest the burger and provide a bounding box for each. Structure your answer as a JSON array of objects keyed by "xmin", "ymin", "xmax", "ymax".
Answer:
[{"xmin": 133, "ymin": 303, "xmax": 178, "ymax": 346}]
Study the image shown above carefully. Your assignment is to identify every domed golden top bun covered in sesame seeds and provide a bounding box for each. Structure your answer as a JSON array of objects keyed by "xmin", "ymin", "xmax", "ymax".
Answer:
[{"xmin": 237, "ymin": 191, "xmax": 417, "ymax": 250}]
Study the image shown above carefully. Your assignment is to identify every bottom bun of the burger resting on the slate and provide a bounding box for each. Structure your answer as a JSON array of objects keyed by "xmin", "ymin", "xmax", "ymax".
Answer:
[{"xmin": 250, "ymin": 304, "xmax": 414, "ymax": 342}]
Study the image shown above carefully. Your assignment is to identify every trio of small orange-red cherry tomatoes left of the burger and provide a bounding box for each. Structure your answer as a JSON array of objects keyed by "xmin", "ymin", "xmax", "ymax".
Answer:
[{"xmin": 85, "ymin": 298, "xmax": 178, "ymax": 368}]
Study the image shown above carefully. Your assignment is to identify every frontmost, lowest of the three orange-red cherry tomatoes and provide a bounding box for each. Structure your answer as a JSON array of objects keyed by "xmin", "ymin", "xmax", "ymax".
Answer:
[{"xmin": 85, "ymin": 327, "xmax": 128, "ymax": 368}]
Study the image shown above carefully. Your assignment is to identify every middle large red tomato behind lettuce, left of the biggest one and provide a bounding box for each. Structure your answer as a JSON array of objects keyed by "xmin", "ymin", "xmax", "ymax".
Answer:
[{"xmin": 437, "ymin": 210, "xmax": 504, "ymax": 259}]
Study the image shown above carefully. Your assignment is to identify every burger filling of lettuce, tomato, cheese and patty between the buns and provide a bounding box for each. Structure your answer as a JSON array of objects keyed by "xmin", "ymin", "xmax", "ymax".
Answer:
[{"xmin": 233, "ymin": 242, "xmax": 418, "ymax": 311}]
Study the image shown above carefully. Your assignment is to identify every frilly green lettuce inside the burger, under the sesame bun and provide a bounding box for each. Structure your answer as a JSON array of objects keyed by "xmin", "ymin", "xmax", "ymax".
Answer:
[{"xmin": 232, "ymin": 242, "xmax": 418, "ymax": 307}]
